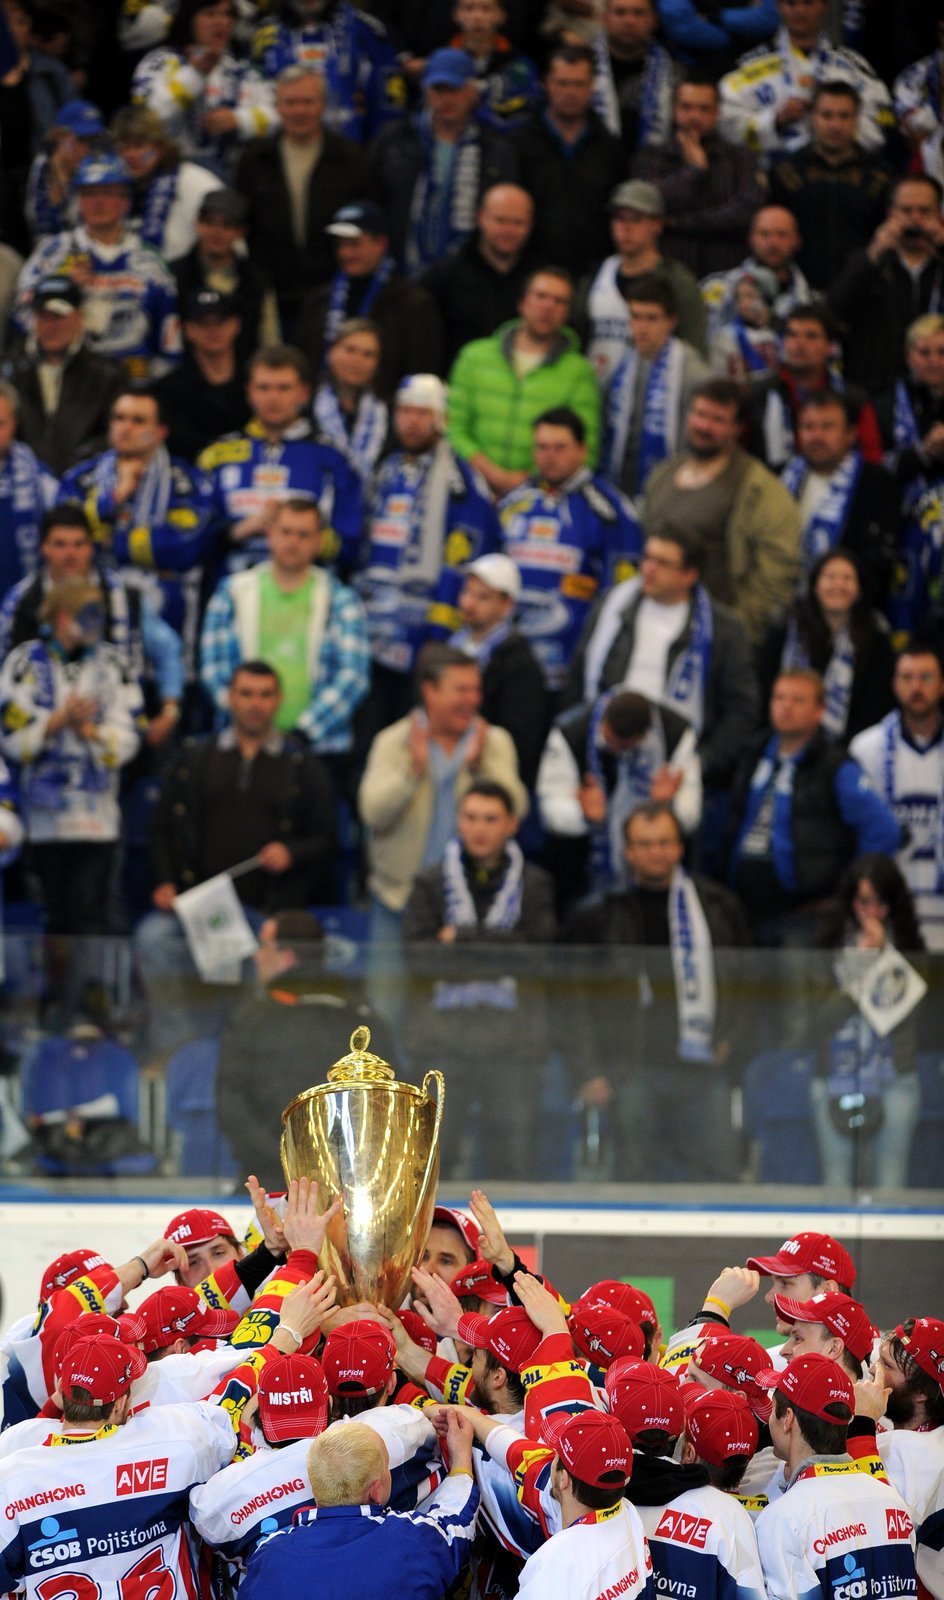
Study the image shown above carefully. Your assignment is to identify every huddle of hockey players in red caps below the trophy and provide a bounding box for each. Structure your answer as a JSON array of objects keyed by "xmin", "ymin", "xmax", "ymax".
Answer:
[{"xmin": 0, "ymin": 1178, "xmax": 944, "ymax": 1600}]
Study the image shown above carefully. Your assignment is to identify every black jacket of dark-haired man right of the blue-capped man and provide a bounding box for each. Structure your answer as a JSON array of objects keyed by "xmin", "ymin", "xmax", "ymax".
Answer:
[{"xmin": 512, "ymin": 110, "xmax": 626, "ymax": 274}]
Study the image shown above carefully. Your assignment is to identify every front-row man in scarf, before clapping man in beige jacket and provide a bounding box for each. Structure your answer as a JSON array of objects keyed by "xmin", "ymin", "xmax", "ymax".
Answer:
[{"xmin": 403, "ymin": 779, "xmax": 555, "ymax": 1178}]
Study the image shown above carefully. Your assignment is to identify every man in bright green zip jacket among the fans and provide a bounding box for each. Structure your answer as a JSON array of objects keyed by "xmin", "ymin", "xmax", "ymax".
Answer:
[{"xmin": 448, "ymin": 267, "xmax": 600, "ymax": 496}]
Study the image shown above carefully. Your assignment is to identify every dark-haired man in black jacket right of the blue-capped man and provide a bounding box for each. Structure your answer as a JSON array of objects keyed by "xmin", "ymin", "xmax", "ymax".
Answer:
[{"xmin": 512, "ymin": 45, "xmax": 626, "ymax": 277}]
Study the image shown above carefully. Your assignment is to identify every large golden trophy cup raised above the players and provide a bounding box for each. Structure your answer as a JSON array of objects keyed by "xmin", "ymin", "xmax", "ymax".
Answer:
[{"xmin": 282, "ymin": 1027, "xmax": 445, "ymax": 1307}]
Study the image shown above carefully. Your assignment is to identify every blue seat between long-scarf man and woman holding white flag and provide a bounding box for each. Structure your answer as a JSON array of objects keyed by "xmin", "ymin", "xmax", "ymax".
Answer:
[{"xmin": 744, "ymin": 1050, "xmax": 819, "ymax": 1184}]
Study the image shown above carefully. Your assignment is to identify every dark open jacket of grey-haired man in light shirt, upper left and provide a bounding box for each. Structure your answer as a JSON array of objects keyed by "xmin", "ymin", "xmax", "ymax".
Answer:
[{"xmin": 235, "ymin": 130, "xmax": 368, "ymax": 306}]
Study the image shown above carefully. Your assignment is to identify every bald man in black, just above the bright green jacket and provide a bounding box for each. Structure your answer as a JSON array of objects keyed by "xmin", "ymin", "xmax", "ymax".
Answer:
[{"xmin": 422, "ymin": 184, "xmax": 541, "ymax": 376}]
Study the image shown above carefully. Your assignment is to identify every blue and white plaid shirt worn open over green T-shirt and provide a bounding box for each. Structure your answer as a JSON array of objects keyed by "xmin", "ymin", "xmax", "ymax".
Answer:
[{"xmin": 200, "ymin": 566, "xmax": 370, "ymax": 755}]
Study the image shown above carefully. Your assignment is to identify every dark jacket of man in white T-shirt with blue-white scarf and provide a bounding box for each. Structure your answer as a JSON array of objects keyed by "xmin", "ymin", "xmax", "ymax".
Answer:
[{"xmin": 565, "ymin": 590, "xmax": 760, "ymax": 787}]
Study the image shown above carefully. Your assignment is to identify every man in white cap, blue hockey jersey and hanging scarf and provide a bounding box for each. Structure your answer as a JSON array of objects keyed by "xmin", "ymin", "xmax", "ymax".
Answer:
[{"xmin": 357, "ymin": 373, "xmax": 499, "ymax": 734}]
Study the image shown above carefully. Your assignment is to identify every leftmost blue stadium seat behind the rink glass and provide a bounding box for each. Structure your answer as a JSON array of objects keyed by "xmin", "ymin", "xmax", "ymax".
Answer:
[{"xmin": 21, "ymin": 1038, "xmax": 157, "ymax": 1178}]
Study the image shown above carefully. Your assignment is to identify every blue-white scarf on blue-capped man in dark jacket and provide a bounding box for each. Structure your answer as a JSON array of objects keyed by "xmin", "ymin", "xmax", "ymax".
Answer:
[{"xmin": 406, "ymin": 112, "xmax": 482, "ymax": 277}]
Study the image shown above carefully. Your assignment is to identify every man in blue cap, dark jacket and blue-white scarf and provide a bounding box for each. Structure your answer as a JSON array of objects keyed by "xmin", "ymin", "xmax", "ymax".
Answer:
[{"xmin": 373, "ymin": 50, "xmax": 517, "ymax": 277}]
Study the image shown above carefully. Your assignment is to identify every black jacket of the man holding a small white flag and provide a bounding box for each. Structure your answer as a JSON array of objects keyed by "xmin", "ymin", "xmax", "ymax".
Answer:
[{"xmin": 150, "ymin": 736, "xmax": 336, "ymax": 914}]
